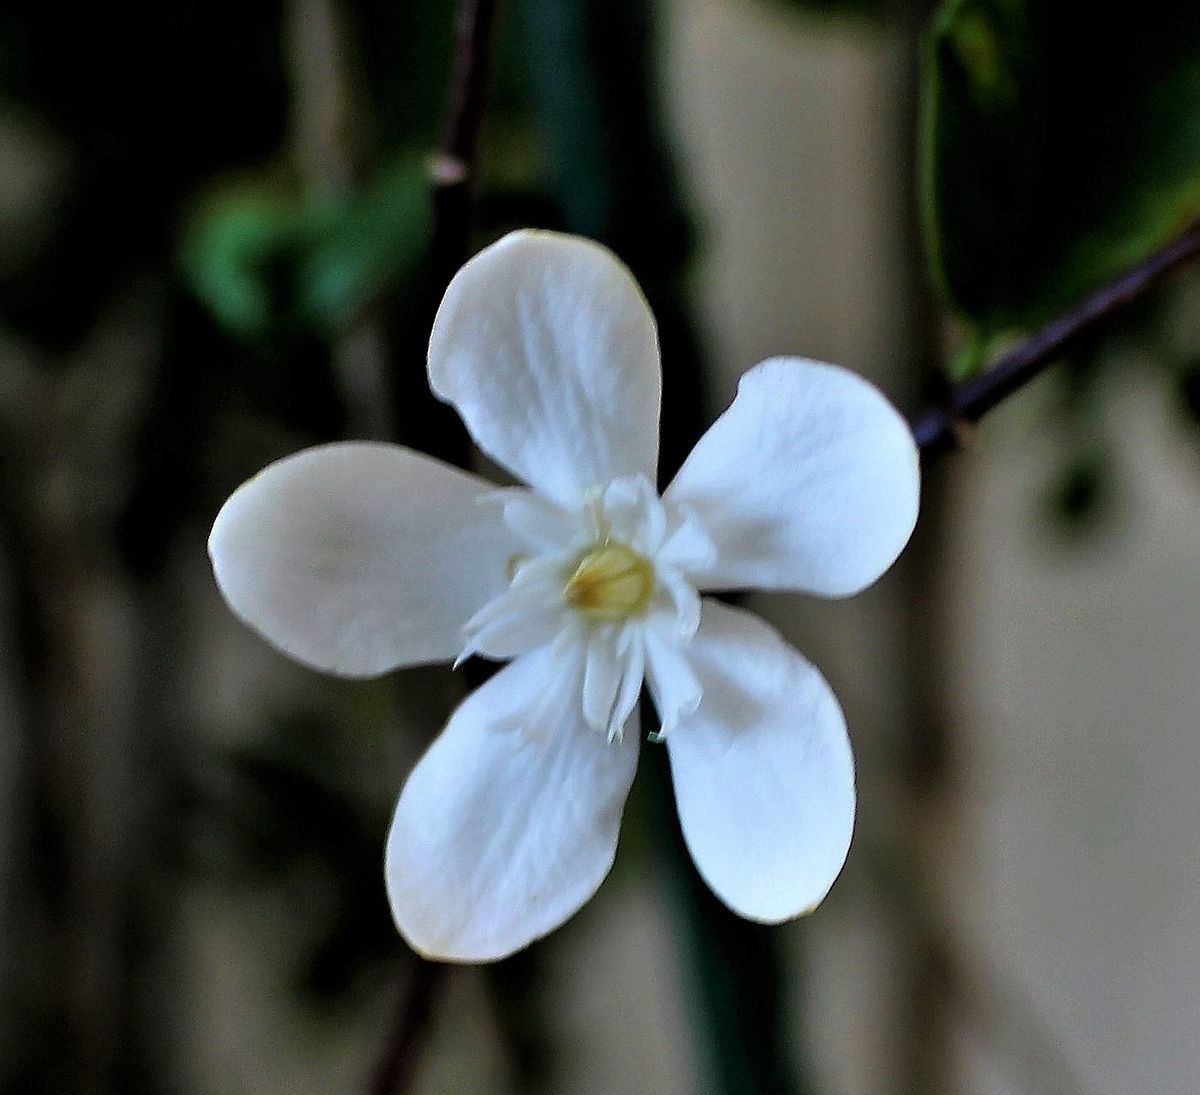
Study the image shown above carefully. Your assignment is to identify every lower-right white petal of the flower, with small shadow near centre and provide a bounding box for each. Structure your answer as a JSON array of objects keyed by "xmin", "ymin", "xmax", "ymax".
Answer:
[{"xmin": 666, "ymin": 600, "xmax": 854, "ymax": 923}]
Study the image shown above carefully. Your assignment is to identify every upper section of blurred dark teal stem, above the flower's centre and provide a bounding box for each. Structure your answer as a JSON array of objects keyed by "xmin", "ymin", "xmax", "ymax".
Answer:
[{"xmin": 521, "ymin": 0, "xmax": 704, "ymax": 481}]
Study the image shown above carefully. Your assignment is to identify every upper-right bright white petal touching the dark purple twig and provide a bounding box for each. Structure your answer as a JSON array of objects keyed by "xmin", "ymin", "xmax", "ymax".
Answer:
[{"xmin": 666, "ymin": 358, "xmax": 920, "ymax": 597}]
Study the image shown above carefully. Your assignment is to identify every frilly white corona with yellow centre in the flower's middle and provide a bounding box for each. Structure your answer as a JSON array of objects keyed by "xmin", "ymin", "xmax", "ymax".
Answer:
[{"xmin": 460, "ymin": 477, "xmax": 713, "ymax": 741}]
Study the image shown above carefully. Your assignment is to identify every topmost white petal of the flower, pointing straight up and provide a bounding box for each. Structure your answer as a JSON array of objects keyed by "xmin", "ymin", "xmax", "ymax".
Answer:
[{"xmin": 428, "ymin": 232, "xmax": 661, "ymax": 507}]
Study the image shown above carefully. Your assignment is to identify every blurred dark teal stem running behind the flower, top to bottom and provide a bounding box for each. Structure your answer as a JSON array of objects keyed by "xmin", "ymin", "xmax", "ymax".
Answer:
[{"xmin": 522, "ymin": 0, "xmax": 812, "ymax": 1095}]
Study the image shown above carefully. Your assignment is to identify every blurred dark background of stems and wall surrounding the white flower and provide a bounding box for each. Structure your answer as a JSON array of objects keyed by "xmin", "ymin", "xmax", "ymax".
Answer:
[{"xmin": 0, "ymin": 0, "xmax": 1200, "ymax": 1095}]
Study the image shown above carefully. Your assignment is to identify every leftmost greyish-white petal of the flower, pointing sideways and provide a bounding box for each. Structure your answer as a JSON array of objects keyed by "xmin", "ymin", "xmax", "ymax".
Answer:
[{"xmin": 209, "ymin": 443, "xmax": 516, "ymax": 677}]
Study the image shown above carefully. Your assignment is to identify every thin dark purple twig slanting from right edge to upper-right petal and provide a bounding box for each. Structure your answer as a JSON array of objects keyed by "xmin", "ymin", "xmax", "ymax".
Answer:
[{"xmin": 912, "ymin": 222, "xmax": 1200, "ymax": 460}]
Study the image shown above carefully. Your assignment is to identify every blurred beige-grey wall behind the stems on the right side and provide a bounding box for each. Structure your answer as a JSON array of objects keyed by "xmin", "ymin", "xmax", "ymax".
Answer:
[{"xmin": 671, "ymin": 0, "xmax": 1200, "ymax": 1095}]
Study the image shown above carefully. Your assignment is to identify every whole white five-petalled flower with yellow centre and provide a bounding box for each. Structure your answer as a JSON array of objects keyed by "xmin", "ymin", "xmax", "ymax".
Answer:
[{"xmin": 209, "ymin": 232, "xmax": 919, "ymax": 961}]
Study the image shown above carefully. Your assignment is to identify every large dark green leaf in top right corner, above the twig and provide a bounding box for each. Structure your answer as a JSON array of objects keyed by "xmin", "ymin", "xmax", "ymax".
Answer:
[{"xmin": 922, "ymin": 0, "xmax": 1200, "ymax": 341}]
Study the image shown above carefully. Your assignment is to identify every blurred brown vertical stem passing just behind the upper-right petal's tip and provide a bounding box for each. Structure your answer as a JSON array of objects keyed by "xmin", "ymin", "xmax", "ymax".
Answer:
[{"xmin": 875, "ymin": 0, "xmax": 958, "ymax": 1095}]
